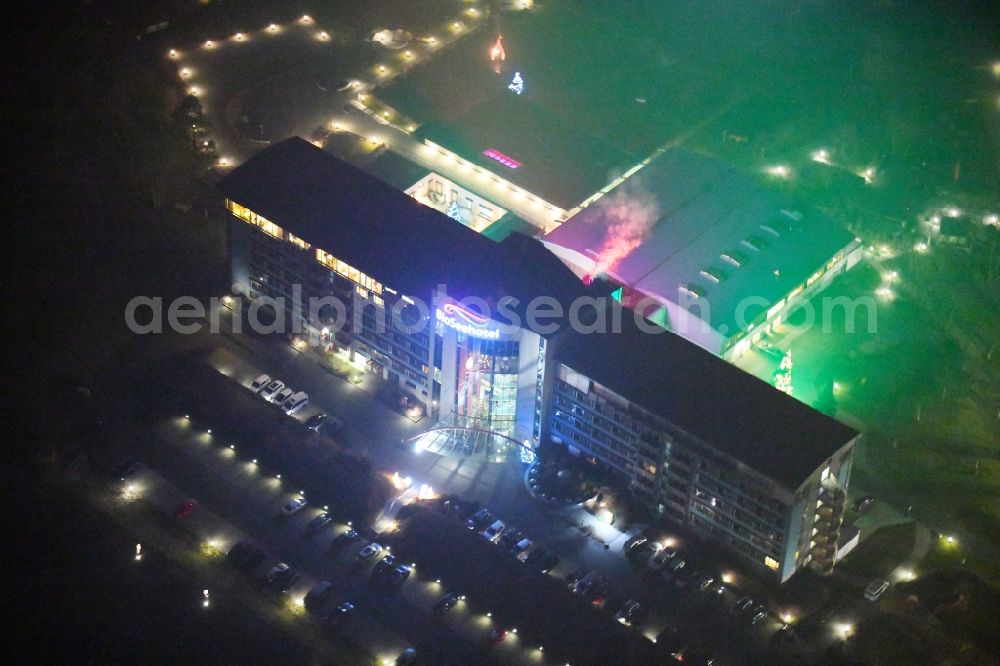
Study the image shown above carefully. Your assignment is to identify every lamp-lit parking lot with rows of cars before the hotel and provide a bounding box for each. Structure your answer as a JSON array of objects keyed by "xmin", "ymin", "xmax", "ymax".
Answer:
[{"xmin": 88, "ymin": 302, "xmax": 804, "ymax": 663}]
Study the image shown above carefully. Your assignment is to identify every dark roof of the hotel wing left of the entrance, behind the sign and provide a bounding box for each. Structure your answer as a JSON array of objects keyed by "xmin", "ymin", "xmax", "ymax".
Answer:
[{"xmin": 219, "ymin": 137, "xmax": 586, "ymax": 322}]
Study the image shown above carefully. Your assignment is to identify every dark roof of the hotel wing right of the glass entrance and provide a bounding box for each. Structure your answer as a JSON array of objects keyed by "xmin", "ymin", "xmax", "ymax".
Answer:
[{"xmin": 555, "ymin": 305, "xmax": 858, "ymax": 490}]
